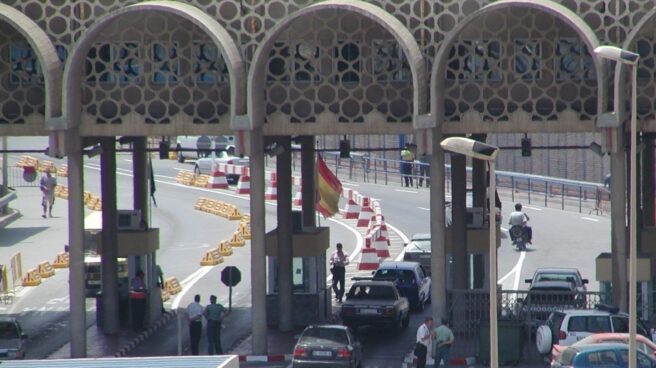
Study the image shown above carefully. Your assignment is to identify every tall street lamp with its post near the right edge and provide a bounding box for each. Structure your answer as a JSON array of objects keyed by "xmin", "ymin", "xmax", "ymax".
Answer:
[{"xmin": 595, "ymin": 46, "xmax": 640, "ymax": 368}]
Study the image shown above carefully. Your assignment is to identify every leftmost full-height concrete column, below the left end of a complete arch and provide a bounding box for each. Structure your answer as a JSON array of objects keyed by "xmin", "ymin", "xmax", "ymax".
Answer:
[{"xmin": 66, "ymin": 129, "xmax": 87, "ymax": 358}]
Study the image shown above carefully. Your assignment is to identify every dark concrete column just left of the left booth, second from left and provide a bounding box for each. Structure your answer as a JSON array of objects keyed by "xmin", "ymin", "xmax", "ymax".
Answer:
[{"xmin": 100, "ymin": 137, "xmax": 120, "ymax": 334}]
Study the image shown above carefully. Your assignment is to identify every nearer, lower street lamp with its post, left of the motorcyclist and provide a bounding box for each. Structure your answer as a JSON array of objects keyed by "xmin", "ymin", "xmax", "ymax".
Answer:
[{"xmin": 440, "ymin": 137, "xmax": 499, "ymax": 367}]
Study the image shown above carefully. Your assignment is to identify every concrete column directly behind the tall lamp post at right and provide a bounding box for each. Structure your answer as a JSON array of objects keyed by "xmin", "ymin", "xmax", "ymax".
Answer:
[{"xmin": 610, "ymin": 128, "xmax": 628, "ymax": 312}]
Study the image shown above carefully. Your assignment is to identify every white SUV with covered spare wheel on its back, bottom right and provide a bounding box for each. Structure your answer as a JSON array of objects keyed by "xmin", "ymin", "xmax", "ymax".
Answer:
[{"xmin": 535, "ymin": 304, "xmax": 651, "ymax": 354}]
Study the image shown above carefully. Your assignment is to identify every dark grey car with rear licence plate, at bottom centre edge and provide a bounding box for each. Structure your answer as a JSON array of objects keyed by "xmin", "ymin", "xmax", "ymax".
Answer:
[{"xmin": 292, "ymin": 325, "xmax": 362, "ymax": 368}]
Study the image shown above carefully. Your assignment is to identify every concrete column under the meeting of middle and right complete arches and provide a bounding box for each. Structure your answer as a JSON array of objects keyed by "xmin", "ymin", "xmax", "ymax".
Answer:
[{"xmin": 429, "ymin": 128, "xmax": 447, "ymax": 318}]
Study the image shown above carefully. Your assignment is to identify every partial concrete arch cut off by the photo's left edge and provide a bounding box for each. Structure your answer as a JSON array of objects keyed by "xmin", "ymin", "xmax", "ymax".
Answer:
[{"xmin": 0, "ymin": 4, "xmax": 62, "ymax": 120}]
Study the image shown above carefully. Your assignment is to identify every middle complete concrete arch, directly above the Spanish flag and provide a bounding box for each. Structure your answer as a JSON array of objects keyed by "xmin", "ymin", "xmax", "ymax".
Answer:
[{"xmin": 248, "ymin": 0, "xmax": 427, "ymax": 129}]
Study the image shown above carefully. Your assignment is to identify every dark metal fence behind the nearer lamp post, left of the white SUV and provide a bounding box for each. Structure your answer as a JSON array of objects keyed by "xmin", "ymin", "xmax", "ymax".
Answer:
[{"xmin": 447, "ymin": 290, "xmax": 612, "ymax": 362}]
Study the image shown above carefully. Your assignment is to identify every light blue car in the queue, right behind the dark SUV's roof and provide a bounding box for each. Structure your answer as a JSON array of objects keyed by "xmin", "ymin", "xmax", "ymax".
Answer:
[{"xmin": 374, "ymin": 261, "xmax": 431, "ymax": 311}]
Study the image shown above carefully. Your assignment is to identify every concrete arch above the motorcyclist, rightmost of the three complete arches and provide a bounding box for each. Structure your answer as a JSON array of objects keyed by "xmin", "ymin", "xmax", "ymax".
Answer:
[{"xmin": 430, "ymin": 0, "xmax": 608, "ymax": 126}]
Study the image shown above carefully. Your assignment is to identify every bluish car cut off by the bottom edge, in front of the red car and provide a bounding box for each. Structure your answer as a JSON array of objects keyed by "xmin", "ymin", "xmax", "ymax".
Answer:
[{"xmin": 552, "ymin": 343, "xmax": 656, "ymax": 368}]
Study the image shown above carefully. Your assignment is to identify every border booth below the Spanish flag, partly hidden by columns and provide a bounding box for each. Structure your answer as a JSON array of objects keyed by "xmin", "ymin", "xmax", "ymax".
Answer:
[{"xmin": 265, "ymin": 223, "xmax": 332, "ymax": 327}]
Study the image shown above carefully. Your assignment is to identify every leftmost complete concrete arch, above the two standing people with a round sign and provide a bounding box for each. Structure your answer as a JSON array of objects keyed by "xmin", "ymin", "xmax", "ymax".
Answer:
[{"xmin": 63, "ymin": 1, "xmax": 246, "ymax": 128}]
